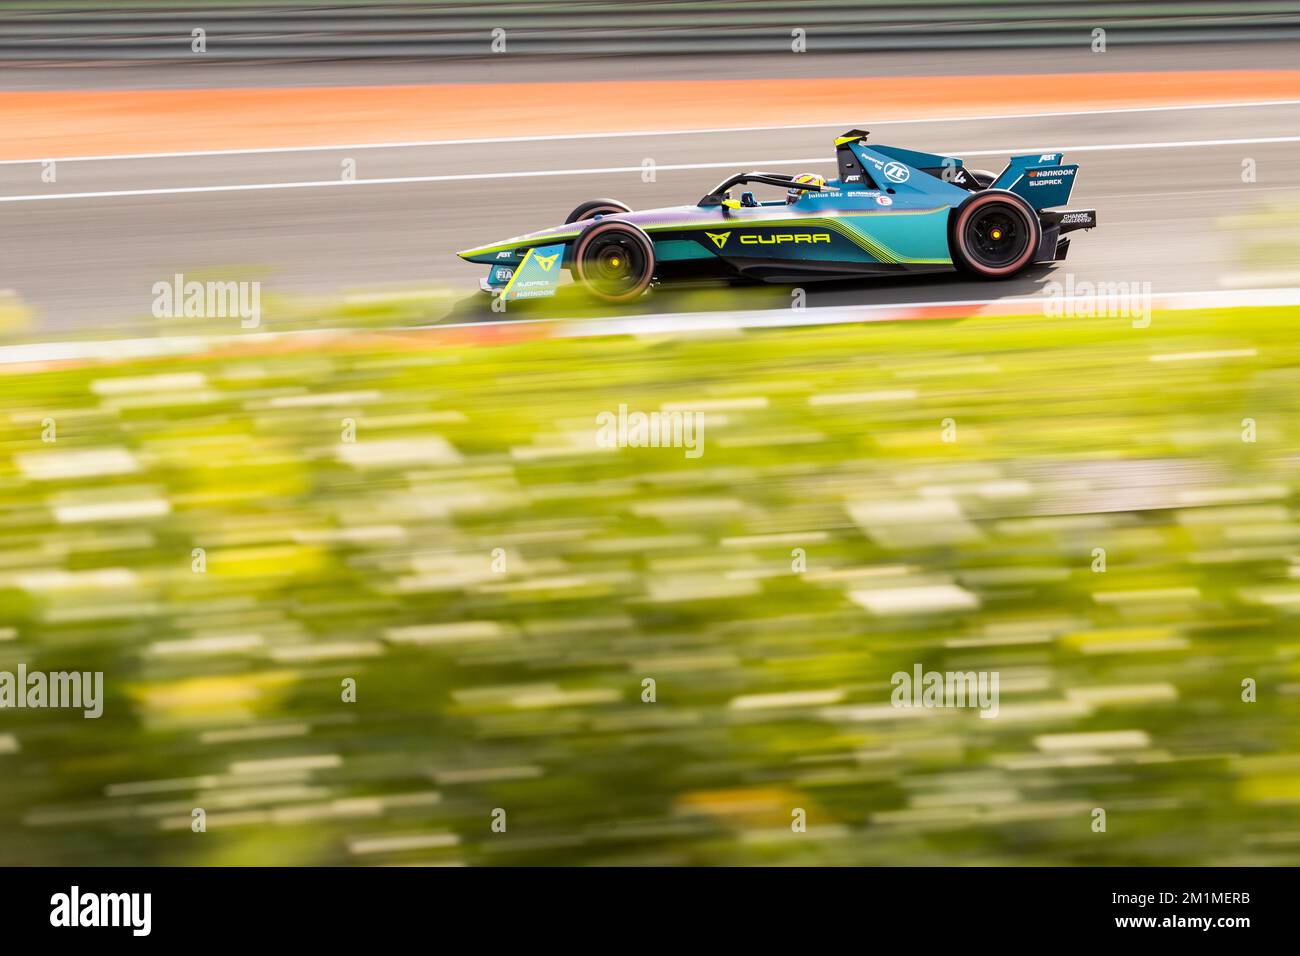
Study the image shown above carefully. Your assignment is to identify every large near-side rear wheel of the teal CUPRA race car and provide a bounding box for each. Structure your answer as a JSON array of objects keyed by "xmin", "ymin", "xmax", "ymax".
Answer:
[{"xmin": 948, "ymin": 189, "xmax": 1043, "ymax": 278}]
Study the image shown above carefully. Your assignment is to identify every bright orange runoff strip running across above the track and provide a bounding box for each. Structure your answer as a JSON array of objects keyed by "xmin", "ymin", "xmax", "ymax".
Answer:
[{"xmin": 0, "ymin": 70, "xmax": 1300, "ymax": 159}]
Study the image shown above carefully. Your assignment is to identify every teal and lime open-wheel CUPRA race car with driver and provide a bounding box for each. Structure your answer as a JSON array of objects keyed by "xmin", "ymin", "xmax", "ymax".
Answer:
[{"xmin": 459, "ymin": 129, "xmax": 1097, "ymax": 302}]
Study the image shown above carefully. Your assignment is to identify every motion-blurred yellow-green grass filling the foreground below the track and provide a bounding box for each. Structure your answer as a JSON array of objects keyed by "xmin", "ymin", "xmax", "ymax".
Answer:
[{"xmin": 0, "ymin": 308, "xmax": 1300, "ymax": 865}]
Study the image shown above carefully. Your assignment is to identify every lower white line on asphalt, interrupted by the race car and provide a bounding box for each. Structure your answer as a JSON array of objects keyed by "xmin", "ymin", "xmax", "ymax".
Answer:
[{"xmin": 0, "ymin": 137, "xmax": 1300, "ymax": 203}]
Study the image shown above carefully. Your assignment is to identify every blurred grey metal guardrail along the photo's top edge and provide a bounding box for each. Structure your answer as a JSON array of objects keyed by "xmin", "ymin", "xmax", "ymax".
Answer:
[{"xmin": 0, "ymin": 0, "xmax": 1300, "ymax": 61}]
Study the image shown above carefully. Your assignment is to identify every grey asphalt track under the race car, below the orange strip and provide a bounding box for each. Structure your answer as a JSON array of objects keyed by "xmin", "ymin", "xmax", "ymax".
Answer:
[{"xmin": 0, "ymin": 55, "xmax": 1300, "ymax": 329}]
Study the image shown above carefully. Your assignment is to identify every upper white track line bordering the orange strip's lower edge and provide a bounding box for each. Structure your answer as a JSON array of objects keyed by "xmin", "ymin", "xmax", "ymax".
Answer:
[{"xmin": 0, "ymin": 100, "xmax": 1300, "ymax": 166}]
